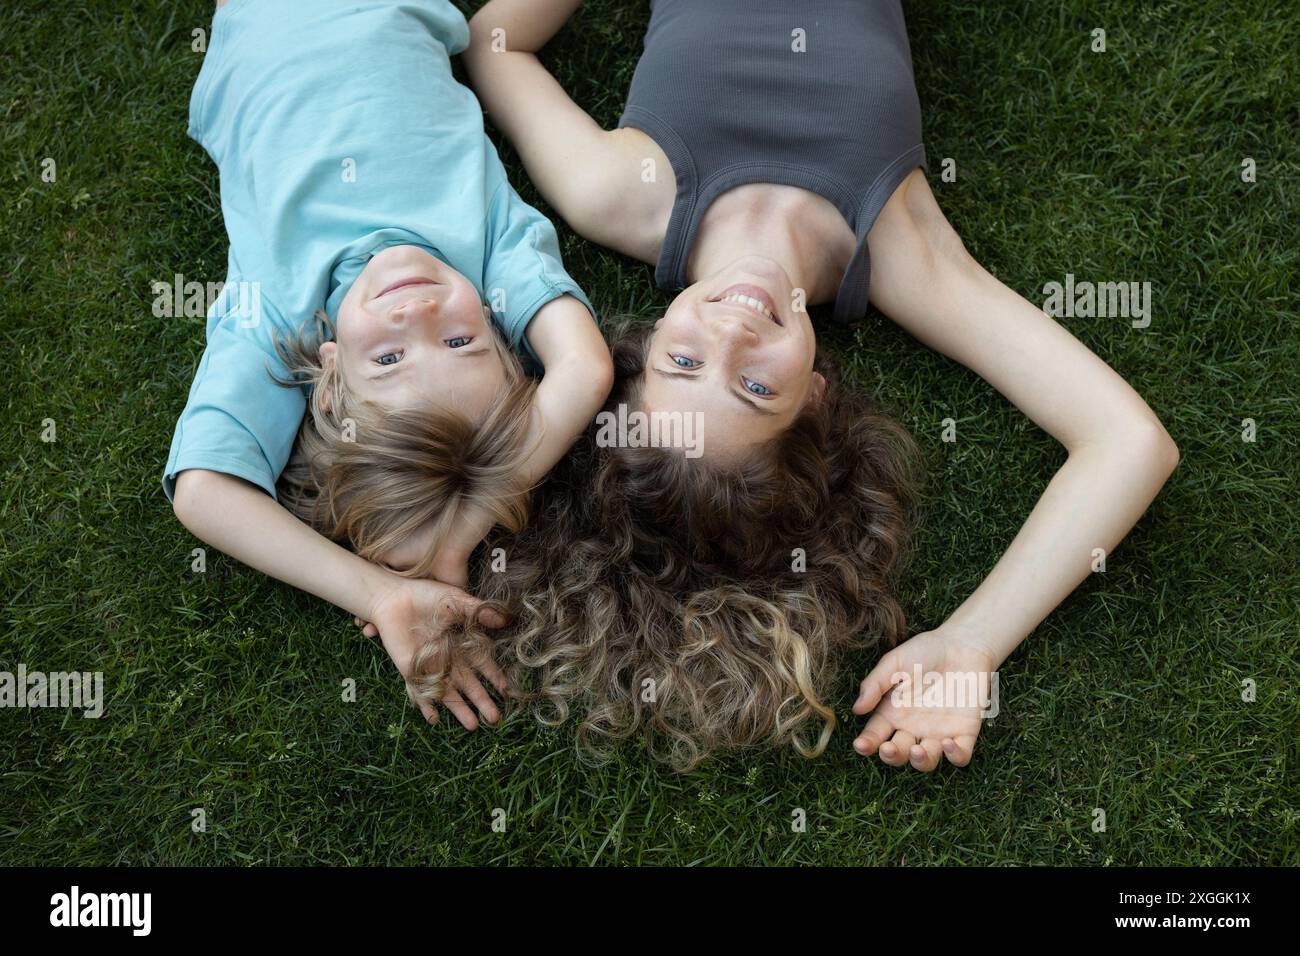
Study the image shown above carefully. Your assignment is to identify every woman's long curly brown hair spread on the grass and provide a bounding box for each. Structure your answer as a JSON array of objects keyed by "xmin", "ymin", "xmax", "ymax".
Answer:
[{"xmin": 452, "ymin": 321, "xmax": 917, "ymax": 770}]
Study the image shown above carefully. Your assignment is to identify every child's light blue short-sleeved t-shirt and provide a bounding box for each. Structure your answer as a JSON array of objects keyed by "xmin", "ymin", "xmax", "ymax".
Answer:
[{"xmin": 163, "ymin": 0, "xmax": 592, "ymax": 498}]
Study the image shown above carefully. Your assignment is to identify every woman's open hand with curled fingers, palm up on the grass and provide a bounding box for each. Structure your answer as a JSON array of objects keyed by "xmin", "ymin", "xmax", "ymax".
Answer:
[{"xmin": 853, "ymin": 630, "xmax": 996, "ymax": 771}]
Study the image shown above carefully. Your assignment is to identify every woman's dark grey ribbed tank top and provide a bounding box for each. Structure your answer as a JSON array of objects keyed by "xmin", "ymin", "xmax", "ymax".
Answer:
[{"xmin": 619, "ymin": 0, "xmax": 926, "ymax": 321}]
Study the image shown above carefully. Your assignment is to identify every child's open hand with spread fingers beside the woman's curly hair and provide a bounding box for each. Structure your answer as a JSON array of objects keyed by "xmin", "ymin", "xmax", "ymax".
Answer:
[{"xmin": 365, "ymin": 579, "xmax": 510, "ymax": 730}]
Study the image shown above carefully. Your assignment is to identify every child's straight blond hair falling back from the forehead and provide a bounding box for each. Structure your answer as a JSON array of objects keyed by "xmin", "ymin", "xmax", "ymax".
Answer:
[{"xmin": 276, "ymin": 312, "xmax": 537, "ymax": 578}]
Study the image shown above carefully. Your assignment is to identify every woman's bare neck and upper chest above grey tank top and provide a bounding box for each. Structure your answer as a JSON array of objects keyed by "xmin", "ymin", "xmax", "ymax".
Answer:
[{"xmin": 686, "ymin": 183, "xmax": 857, "ymax": 304}]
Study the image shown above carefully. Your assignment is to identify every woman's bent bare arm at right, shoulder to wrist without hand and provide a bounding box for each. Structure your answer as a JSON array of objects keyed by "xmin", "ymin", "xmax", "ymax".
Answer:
[{"xmin": 868, "ymin": 172, "xmax": 1178, "ymax": 662}]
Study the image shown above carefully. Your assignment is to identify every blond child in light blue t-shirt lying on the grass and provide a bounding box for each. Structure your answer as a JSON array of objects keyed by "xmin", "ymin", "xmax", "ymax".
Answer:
[{"xmin": 164, "ymin": 0, "xmax": 612, "ymax": 728}]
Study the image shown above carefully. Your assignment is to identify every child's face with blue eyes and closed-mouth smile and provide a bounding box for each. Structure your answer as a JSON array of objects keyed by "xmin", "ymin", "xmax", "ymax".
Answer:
[{"xmin": 321, "ymin": 246, "xmax": 506, "ymax": 421}]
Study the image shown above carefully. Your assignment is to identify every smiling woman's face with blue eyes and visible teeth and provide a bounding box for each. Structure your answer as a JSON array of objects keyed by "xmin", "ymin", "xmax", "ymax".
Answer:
[{"xmin": 641, "ymin": 256, "xmax": 826, "ymax": 454}]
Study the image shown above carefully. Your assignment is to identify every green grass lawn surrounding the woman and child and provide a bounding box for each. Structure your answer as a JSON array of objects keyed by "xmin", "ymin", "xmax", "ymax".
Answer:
[{"xmin": 0, "ymin": 0, "xmax": 1300, "ymax": 865}]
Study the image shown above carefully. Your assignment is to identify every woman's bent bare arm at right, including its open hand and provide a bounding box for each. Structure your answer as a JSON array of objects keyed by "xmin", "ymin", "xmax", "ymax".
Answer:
[{"xmin": 853, "ymin": 172, "xmax": 1178, "ymax": 771}]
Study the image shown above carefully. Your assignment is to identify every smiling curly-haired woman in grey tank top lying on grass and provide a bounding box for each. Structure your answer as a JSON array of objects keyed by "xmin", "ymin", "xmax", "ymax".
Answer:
[{"xmin": 454, "ymin": 0, "xmax": 1178, "ymax": 770}]
